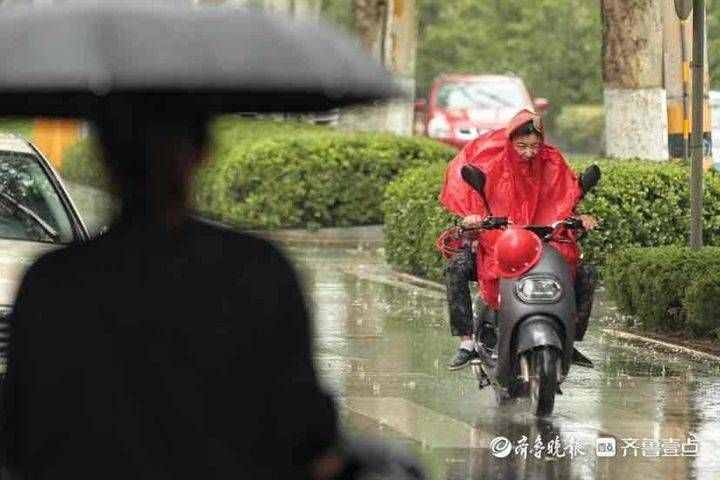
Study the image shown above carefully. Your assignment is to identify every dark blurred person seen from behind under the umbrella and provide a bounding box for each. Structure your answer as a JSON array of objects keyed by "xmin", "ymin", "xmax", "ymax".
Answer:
[{"xmin": 3, "ymin": 106, "xmax": 420, "ymax": 480}]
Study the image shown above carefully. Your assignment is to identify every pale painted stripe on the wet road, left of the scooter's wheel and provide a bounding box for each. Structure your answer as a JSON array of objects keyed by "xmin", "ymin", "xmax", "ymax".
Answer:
[{"xmin": 340, "ymin": 397, "xmax": 492, "ymax": 449}]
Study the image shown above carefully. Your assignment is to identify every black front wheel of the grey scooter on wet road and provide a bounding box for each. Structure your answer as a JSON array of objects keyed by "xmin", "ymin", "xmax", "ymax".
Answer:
[{"xmin": 526, "ymin": 347, "xmax": 560, "ymax": 417}]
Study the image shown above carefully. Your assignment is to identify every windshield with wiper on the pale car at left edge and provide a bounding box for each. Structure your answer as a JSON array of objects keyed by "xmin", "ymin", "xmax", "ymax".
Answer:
[{"xmin": 0, "ymin": 151, "xmax": 74, "ymax": 243}]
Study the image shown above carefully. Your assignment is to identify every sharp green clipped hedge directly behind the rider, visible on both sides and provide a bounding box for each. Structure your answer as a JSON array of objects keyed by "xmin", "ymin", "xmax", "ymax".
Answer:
[{"xmin": 384, "ymin": 157, "xmax": 720, "ymax": 279}]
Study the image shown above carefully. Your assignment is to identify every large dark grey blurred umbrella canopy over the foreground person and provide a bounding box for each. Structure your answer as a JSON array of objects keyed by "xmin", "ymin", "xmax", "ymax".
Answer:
[{"xmin": 0, "ymin": 2, "xmax": 400, "ymax": 116}]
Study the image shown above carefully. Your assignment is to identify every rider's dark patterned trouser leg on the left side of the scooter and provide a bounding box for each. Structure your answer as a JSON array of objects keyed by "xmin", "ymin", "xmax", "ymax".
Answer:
[{"xmin": 445, "ymin": 247, "xmax": 475, "ymax": 337}]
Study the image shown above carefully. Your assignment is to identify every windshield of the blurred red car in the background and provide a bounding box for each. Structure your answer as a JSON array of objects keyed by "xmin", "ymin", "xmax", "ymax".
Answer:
[{"xmin": 437, "ymin": 81, "xmax": 526, "ymax": 109}]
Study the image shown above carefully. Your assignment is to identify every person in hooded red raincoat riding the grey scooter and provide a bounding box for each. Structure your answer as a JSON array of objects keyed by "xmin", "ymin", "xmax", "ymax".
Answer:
[{"xmin": 439, "ymin": 110, "xmax": 595, "ymax": 369}]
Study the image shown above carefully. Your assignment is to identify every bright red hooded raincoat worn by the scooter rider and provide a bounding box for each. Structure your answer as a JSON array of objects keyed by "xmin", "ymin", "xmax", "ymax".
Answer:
[{"xmin": 440, "ymin": 110, "xmax": 582, "ymax": 309}]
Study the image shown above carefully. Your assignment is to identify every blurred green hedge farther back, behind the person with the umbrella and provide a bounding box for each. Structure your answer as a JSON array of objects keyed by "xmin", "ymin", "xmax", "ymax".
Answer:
[{"xmin": 63, "ymin": 117, "xmax": 454, "ymax": 229}]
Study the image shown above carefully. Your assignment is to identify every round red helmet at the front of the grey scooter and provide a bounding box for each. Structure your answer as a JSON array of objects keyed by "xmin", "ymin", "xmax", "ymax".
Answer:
[{"xmin": 495, "ymin": 228, "xmax": 542, "ymax": 277}]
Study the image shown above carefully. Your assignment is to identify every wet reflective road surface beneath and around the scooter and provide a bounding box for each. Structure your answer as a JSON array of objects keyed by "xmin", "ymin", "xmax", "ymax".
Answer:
[{"xmin": 286, "ymin": 246, "xmax": 720, "ymax": 480}]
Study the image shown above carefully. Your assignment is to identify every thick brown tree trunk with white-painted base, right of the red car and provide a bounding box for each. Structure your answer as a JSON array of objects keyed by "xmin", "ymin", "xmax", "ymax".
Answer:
[{"xmin": 601, "ymin": 0, "xmax": 668, "ymax": 160}]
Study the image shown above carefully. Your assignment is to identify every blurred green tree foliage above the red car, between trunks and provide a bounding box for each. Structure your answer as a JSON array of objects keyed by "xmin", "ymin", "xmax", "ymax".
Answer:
[{"xmin": 417, "ymin": 0, "xmax": 602, "ymax": 124}]
